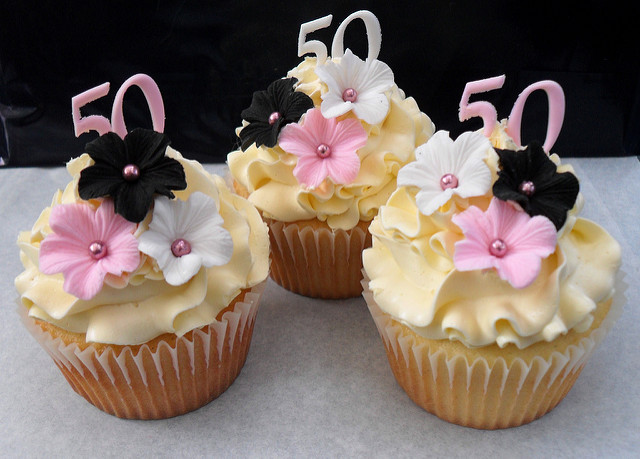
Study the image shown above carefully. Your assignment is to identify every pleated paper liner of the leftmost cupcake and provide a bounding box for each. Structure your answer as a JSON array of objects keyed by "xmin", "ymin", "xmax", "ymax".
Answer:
[{"xmin": 18, "ymin": 281, "xmax": 266, "ymax": 419}]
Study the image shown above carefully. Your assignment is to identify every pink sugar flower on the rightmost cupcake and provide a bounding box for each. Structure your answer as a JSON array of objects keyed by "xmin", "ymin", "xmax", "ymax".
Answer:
[{"xmin": 452, "ymin": 198, "xmax": 557, "ymax": 288}]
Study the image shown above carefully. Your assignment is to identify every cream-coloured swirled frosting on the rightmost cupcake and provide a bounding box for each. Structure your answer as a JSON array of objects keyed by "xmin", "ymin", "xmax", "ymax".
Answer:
[{"xmin": 363, "ymin": 126, "xmax": 621, "ymax": 348}]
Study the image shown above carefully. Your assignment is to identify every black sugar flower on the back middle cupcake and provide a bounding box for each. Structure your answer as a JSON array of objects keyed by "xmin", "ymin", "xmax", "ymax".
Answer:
[{"xmin": 240, "ymin": 78, "xmax": 313, "ymax": 150}]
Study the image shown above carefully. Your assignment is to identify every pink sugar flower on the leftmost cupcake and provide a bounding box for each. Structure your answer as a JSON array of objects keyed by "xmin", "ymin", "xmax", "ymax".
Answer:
[{"xmin": 39, "ymin": 199, "xmax": 140, "ymax": 300}]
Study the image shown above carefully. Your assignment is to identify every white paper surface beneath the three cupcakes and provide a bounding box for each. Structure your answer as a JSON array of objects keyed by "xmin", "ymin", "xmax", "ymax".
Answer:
[{"xmin": 0, "ymin": 157, "xmax": 640, "ymax": 457}]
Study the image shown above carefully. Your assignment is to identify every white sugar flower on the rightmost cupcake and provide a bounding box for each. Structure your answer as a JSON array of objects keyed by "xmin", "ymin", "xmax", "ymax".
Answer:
[{"xmin": 398, "ymin": 131, "xmax": 492, "ymax": 215}]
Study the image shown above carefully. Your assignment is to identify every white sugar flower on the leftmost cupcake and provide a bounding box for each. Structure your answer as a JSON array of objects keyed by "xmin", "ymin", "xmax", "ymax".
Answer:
[{"xmin": 138, "ymin": 192, "xmax": 233, "ymax": 285}]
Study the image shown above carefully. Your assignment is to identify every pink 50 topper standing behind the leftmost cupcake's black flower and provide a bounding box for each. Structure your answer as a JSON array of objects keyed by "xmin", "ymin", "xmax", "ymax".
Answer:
[{"xmin": 71, "ymin": 73, "xmax": 164, "ymax": 138}]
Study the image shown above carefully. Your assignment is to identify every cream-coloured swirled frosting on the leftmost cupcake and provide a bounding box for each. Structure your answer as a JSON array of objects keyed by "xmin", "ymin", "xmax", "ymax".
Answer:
[{"xmin": 15, "ymin": 147, "xmax": 269, "ymax": 345}]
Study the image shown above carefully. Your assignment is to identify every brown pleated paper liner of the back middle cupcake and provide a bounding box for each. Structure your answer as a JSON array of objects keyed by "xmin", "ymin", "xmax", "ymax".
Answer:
[{"xmin": 265, "ymin": 219, "xmax": 371, "ymax": 299}]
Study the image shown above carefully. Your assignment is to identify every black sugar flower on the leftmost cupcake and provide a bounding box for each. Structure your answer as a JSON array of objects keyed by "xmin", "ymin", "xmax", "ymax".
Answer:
[{"xmin": 78, "ymin": 129, "xmax": 187, "ymax": 223}]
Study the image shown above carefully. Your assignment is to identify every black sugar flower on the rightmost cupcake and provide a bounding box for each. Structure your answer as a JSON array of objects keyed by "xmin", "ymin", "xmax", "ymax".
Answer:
[{"xmin": 493, "ymin": 143, "xmax": 580, "ymax": 230}]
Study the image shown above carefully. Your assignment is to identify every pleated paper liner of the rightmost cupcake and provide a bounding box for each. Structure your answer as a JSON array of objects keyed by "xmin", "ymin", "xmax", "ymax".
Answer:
[{"xmin": 363, "ymin": 276, "xmax": 626, "ymax": 429}]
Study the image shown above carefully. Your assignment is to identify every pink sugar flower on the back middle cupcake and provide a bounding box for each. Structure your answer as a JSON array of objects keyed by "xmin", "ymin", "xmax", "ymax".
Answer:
[{"xmin": 279, "ymin": 108, "xmax": 367, "ymax": 188}]
